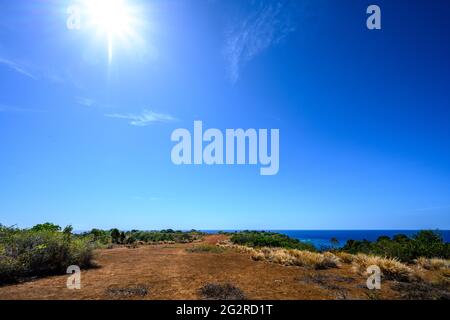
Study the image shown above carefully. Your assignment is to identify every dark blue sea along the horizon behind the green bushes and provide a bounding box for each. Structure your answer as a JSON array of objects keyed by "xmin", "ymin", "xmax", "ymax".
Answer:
[{"xmin": 206, "ymin": 230, "xmax": 450, "ymax": 249}]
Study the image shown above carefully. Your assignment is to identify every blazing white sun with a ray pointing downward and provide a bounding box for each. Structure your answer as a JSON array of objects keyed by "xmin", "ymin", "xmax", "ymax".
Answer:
[{"xmin": 85, "ymin": 0, "xmax": 135, "ymax": 63}]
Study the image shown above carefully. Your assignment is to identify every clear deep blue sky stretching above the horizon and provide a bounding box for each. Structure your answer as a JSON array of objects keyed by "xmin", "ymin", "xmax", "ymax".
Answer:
[{"xmin": 0, "ymin": 0, "xmax": 450, "ymax": 230}]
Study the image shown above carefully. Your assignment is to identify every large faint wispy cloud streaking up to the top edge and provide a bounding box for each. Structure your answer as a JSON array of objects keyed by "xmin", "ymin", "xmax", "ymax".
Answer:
[{"xmin": 224, "ymin": 1, "xmax": 295, "ymax": 83}]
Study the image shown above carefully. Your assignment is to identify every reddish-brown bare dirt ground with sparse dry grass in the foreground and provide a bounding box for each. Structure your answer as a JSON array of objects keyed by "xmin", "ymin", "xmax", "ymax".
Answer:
[{"xmin": 0, "ymin": 235, "xmax": 442, "ymax": 300}]
